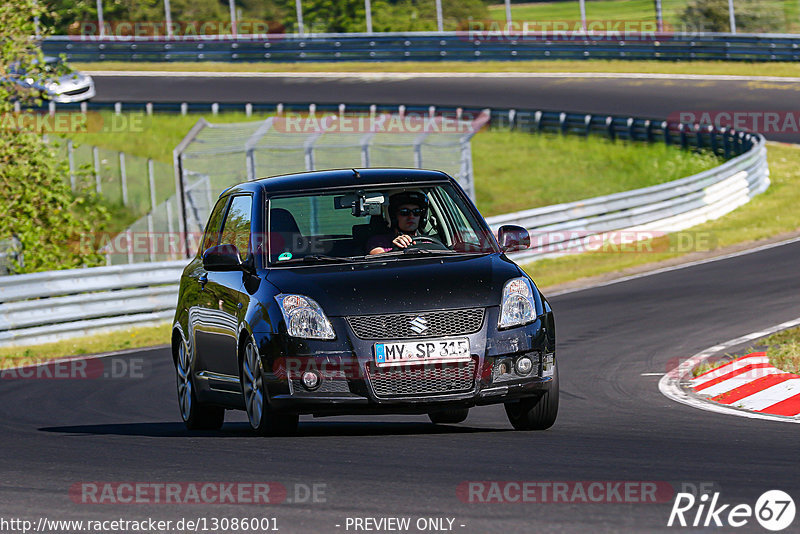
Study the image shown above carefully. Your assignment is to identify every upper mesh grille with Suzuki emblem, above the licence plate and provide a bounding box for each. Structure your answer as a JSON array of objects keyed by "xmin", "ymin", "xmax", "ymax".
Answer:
[{"xmin": 347, "ymin": 308, "xmax": 483, "ymax": 339}]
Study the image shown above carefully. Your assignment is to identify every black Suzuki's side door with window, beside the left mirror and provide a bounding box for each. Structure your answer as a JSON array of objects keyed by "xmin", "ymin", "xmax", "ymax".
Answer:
[{"xmin": 201, "ymin": 195, "xmax": 253, "ymax": 382}]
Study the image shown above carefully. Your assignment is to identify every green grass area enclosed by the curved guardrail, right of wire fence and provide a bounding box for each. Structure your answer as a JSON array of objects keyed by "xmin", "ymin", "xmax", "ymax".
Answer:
[{"xmin": 472, "ymin": 131, "xmax": 721, "ymax": 216}]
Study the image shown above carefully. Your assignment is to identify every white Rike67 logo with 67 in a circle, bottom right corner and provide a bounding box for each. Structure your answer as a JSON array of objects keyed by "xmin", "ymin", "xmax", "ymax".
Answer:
[{"xmin": 667, "ymin": 490, "xmax": 795, "ymax": 531}]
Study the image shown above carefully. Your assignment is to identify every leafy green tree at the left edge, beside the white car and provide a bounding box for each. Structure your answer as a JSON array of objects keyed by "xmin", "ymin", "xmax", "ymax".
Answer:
[{"xmin": 0, "ymin": 0, "xmax": 107, "ymax": 272}]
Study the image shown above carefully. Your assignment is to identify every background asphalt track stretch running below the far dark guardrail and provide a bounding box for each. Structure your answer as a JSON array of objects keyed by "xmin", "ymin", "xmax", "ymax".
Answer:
[{"xmin": 94, "ymin": 73, "xmax": 800, "ymax": 142}]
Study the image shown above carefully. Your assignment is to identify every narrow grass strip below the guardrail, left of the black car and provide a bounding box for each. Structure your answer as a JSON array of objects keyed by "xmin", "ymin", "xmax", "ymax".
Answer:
[{"xmin": 0, "ymin": 323, "xmax": 171, "ymax": 369}]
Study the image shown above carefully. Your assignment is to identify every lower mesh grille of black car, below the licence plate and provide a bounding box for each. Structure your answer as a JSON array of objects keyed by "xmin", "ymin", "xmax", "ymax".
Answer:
[{"xmin": 367, "ymin": 358, "xmax": 475, "ymax": 398}]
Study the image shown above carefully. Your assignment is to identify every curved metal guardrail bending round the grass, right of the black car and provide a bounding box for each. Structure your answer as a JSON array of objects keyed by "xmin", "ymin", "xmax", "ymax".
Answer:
[{"xmin": 487, "ymin": 110, "xmax": 770, "ymax": 261}]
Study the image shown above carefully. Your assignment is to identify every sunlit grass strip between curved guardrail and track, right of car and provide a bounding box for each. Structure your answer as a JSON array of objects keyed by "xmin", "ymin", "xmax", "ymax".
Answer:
[{"xmin": 524, "ymin": 143, "xmax": 800, "ymax": 287}]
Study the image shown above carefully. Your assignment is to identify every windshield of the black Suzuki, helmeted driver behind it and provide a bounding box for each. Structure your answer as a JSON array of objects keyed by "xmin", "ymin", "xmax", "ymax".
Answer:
[{"xmin": 267, "ymin": 184, "xmax": 499, "ymax": 265}]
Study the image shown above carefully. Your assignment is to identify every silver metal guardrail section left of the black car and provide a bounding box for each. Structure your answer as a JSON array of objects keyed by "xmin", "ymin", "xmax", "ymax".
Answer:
[{"xmin": 0, "ymin": 260, "xmax": 187, "ymax": 346}]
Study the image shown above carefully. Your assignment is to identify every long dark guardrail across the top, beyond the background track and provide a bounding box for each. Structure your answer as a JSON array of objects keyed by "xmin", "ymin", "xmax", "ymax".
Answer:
[{"xmin": 42, "ymin": 31, "xmax": 800, "ymax": 62}]
